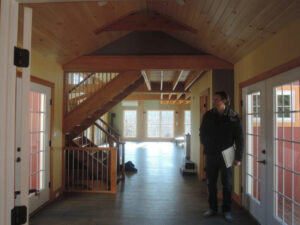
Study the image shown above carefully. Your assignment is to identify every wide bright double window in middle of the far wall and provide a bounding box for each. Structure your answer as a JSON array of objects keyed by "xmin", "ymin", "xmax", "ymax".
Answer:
[{"xmin": 147, "ymin": 111, "xmax": 174, "ymax": 138}]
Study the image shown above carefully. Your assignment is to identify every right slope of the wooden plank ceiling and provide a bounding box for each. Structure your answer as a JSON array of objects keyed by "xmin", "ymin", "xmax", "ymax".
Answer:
[{"xmin": 151, "ymin": 0, "xmax": 300, "ymax": 63}]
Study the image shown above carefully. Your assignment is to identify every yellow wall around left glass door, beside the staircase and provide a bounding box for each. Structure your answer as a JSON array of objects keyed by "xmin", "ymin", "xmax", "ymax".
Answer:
[{"xmin": 31, "ymin": 50, "xmax": 63, "ymax": 191}]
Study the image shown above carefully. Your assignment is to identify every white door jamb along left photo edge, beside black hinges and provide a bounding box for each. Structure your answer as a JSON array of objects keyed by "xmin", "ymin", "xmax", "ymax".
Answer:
[{"xmin": 0, "ymin": 0, "xmax": 19, "ymax": 225}]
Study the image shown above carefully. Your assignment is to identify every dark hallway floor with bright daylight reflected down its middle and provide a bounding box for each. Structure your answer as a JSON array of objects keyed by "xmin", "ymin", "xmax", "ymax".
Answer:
[{"xmin": 30, "ymin": 142, "xmax": 256, "ymax": 225}]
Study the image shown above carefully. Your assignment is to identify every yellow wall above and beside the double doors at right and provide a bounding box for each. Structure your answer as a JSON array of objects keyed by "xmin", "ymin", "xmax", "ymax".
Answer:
[{"xmin": 234, "ymin": 19, "xmax": 300, "ymax": 194}]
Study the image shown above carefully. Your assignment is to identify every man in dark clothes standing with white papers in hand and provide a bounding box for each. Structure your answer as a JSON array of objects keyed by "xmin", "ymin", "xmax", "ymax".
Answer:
[{"xmin": 200, "ymin": 91, "xmax": 244, "ymax": 222}]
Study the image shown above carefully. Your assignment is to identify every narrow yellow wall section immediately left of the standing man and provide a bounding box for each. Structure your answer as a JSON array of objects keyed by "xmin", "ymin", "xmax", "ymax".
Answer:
[{"xmin": 191, "ymin": 70, "xmax": 212, "ymax": 167}]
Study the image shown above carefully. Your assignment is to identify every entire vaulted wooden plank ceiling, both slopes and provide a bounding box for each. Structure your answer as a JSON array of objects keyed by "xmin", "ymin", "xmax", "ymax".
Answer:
[{"xmin": 19, "ymin": 0, "xmax": 300, "ymax": 64}]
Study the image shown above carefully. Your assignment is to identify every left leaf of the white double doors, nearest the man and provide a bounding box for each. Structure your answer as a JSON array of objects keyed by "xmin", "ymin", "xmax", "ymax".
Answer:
[{"xmin": 243, "ymin": 82, "xmax": 267, "ymax": 224}]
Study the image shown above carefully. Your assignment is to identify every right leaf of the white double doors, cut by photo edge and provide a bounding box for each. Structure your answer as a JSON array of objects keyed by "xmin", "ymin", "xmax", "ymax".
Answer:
[{"xmin": 267, "ymin": 68, "xmax": 300, "ymax": 225}]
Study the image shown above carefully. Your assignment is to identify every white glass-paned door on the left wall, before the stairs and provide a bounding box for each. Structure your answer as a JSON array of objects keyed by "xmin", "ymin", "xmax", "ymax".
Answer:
[{"xmin": 15, "ymin": 78, "xmax": 51, "ymax": 213}]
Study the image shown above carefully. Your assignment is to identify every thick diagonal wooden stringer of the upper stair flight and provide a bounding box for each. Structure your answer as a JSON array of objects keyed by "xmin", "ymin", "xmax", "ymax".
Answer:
[{"xmin": 63, "ymin": 71, "xmax": 144, "ymax": 140}]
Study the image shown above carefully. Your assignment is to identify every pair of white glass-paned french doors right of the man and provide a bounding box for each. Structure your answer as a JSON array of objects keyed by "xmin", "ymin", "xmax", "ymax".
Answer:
[{"xmin": 243, "ymin": 68, "xmax": 300, "ymax": 225}]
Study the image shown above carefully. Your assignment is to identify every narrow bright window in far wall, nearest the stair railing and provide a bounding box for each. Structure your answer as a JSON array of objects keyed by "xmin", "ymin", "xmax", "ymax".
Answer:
[{"xmin": 123, "ymin": 110, "xmax": 137, "ymax": 138}]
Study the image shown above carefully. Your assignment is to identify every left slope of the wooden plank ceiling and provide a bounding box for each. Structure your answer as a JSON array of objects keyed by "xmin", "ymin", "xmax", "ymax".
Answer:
[{"xmin": 19, "ymin": 1, "xmax": 145, "ymax": 64}]
